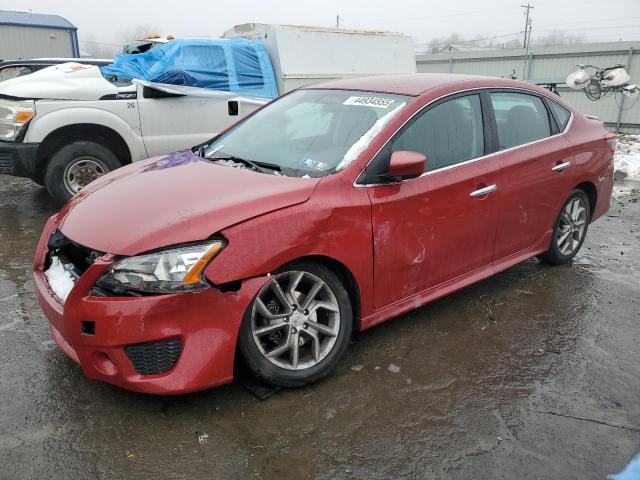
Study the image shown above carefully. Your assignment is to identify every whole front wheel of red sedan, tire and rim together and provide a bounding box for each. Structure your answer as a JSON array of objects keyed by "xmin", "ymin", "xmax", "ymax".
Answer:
[{"xmin": 238, "ymin": 261, "xmax": 353, "ymax": 387}]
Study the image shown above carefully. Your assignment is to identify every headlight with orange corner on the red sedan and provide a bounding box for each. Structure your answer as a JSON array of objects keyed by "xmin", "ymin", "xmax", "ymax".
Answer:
[{"xmin": 96, "ymin": 240, "xmax": 225, "ymax": 294}]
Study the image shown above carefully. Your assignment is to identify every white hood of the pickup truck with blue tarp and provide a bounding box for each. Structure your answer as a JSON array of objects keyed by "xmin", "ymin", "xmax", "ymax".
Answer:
[{"xmin": 0, "ymin": 62, "xmax": 118, "ymax": 100}]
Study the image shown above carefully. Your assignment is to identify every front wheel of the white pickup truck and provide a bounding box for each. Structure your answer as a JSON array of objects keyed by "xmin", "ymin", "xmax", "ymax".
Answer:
[{"xmin": 44, "ymin": 141, "xmax": 122, "ymax": 204}]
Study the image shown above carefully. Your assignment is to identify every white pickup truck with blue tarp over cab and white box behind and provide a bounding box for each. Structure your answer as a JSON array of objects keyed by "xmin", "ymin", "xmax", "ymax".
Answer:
[{"xmin": 0, "ymin": 24, "xmax": 416, "ymax": 203}]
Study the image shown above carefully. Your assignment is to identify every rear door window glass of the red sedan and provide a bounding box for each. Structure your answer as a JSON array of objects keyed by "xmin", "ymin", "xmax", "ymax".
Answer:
[{"xmin": 490, "ymin": 92, "xmax": 551, "ymax": 150}]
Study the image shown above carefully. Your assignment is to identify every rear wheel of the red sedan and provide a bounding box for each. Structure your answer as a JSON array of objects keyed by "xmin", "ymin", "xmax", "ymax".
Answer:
[{"xmin": 538, "ymin": 189, "xmax": 591, "ymax": 265}]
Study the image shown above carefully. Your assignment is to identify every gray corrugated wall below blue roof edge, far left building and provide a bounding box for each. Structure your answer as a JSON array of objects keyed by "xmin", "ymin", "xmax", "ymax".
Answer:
[{"xmin": 0, "ymin": 25, "xmax": 73, "ymax": 60}]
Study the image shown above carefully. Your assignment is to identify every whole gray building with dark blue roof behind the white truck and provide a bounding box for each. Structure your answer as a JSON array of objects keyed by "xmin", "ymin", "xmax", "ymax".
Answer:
[{"xmin": 0, "ymin": 10, "xmax": 80, "ymax": 60}]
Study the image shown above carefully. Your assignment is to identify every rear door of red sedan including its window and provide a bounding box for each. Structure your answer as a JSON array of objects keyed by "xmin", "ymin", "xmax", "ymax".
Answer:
[{"xmin": 488, "ymin": 91, "xmax": 572, "ymax": 260}]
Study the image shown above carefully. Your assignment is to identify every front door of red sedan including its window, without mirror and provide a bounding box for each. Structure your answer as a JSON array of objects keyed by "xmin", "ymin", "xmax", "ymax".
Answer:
[{"xmin": 367, "ymin": 93, "xmax": 500, "ymax": 308}]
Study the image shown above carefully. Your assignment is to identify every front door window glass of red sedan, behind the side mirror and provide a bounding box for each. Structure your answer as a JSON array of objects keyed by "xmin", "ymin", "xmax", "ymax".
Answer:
[{"xmin": 391, "ymin": 95, "xmax": 484, "ymax": 171}]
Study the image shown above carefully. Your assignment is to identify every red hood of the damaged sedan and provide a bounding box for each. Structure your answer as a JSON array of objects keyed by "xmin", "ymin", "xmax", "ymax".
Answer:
[{"xmin": 59, "ymin": 150, "xmax": 320, "ymax": 255}]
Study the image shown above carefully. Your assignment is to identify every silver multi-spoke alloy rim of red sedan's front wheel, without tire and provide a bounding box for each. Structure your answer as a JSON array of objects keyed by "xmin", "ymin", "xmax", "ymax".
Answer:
[{"xmin": 251, "ymin": 271, "xmax": 340, "ymax": 370}]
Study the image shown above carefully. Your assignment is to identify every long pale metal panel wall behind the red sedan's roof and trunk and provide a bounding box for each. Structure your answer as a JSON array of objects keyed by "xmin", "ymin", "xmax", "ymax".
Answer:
[{"xmin": 416, "ymin": 41, "xmax": 640, "ymax": 133}]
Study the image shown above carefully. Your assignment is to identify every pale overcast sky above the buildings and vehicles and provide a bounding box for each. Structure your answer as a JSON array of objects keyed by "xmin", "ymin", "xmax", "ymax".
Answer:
[{"xmin": 0, "ymin": 0, "xmax": 640, "ymax": 52}]
